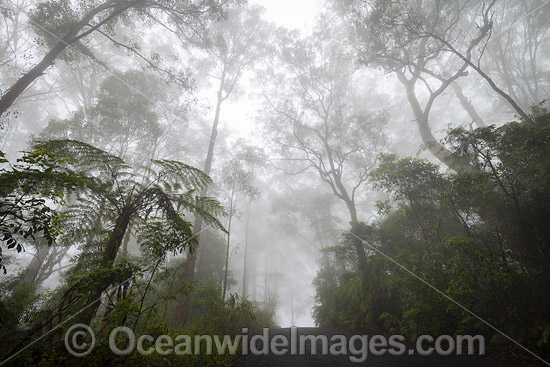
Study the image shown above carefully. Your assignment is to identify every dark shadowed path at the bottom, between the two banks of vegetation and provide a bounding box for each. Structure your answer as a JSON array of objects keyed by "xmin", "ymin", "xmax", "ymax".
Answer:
[{"xmin": 237, "ymin": 328, "xmax": 521, "ymax": 367}]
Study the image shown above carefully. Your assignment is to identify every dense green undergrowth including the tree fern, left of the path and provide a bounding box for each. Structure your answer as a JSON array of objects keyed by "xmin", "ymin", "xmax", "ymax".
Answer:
[{"xmin": 0, "ymin": 140, "xmax": 272, "ymax": 365}]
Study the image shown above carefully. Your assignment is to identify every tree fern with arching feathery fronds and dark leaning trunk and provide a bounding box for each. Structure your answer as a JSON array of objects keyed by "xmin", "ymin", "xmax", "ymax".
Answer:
[{"xmin": 25, "ymin": 140, "xmax": 223, "ymax": 330}]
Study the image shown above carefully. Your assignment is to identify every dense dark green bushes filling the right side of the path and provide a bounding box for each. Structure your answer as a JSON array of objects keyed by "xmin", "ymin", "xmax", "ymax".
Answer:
[{"xmin": 315, "ymin": 109, "xmax": 550, "ymax": 353}]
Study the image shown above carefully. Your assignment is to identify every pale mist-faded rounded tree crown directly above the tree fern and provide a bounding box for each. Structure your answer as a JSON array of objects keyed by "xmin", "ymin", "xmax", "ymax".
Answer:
[{"xmin": 38, "ymin": 71, "xmax": 166, "ymax": 163}]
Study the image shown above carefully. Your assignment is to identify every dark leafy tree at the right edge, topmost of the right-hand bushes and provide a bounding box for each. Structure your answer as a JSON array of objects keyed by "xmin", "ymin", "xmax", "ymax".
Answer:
[{"xmin": 448, "ymin": 106, "xmax": 550, "ymax": 268}]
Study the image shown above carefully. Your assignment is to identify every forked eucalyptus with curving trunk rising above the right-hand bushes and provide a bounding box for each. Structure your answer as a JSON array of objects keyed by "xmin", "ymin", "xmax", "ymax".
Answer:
[{"xmin": 333, "ymin": 0, "xmax": 540, "ymax": 171}]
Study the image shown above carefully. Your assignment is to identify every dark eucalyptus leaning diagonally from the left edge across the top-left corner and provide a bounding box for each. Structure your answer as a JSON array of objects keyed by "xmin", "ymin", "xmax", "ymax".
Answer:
[{"xmin": 0, "ymin": 0, "xmax": 231, "ymax": 116}]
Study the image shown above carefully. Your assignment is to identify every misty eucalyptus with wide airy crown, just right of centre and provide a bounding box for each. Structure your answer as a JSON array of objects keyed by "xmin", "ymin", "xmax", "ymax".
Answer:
[{"xmin": 263, "ymin": 24, "xmax": 386, "ymax": 270}]
